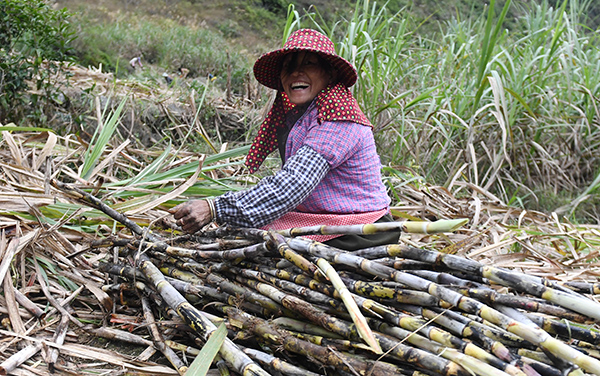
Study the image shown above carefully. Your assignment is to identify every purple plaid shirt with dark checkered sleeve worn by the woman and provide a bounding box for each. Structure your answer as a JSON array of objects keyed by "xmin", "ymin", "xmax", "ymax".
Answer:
[{"xmin": 215, "ymin": 103, "xmax": 390, "ymax": 227}]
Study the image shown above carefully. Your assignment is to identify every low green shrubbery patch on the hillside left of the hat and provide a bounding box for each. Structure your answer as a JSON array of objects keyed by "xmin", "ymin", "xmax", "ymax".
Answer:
[{"xmin": 74, "ymin": 15, "xmax": 249, "ymax": 91}]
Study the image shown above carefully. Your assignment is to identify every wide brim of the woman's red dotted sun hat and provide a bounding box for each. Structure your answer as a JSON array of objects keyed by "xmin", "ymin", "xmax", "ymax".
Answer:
[{"xmin": 253, "ymin": 47, "xmax": 358, "ymax": 90}]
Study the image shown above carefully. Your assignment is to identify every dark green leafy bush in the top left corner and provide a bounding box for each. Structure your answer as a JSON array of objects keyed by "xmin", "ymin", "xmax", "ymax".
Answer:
[{"xmin": 0, "ymin": 0, "xmax": 74, "ymax": 122}]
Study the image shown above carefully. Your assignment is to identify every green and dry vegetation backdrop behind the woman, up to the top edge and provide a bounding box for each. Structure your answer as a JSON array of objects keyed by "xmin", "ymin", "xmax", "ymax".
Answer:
[{"xmin": 0, "ymin": 0, "xmax": 600, "ymax": 222}]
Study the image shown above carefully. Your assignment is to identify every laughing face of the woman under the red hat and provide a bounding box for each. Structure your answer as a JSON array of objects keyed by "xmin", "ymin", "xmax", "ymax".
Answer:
[{"xmin": 280, "ymin": 52, "xmax": 332, "ymax": 105}]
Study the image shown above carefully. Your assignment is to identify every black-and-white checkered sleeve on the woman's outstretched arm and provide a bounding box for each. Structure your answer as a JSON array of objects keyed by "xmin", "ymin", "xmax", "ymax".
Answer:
[{"xmin": 215, "ymin": 146, "xmax": 329, "ymax": 228}]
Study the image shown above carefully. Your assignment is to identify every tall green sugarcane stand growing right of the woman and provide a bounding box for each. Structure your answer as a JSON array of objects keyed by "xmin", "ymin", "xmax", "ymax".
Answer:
[{"xmin": 283, "ymin": 0, "xmax": 600, "ymax": 219}]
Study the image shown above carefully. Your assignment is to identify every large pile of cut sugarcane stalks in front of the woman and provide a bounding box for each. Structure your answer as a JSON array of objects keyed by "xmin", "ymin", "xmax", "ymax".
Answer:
[{"xmin": 43, "ymin": 181, "xmax": 600, "ymax": 376}]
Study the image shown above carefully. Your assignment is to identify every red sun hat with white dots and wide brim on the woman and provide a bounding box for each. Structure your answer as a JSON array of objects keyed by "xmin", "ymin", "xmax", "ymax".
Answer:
[{"xmin": 254, "ymin": 29, "xmax": 357, "ymax": 90}]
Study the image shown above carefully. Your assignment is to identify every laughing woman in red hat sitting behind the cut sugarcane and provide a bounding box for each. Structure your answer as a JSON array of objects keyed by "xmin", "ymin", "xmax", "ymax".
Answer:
[{"xmin": 171, "ymin": 29, "xmax": 399, "ymax": 250}]
